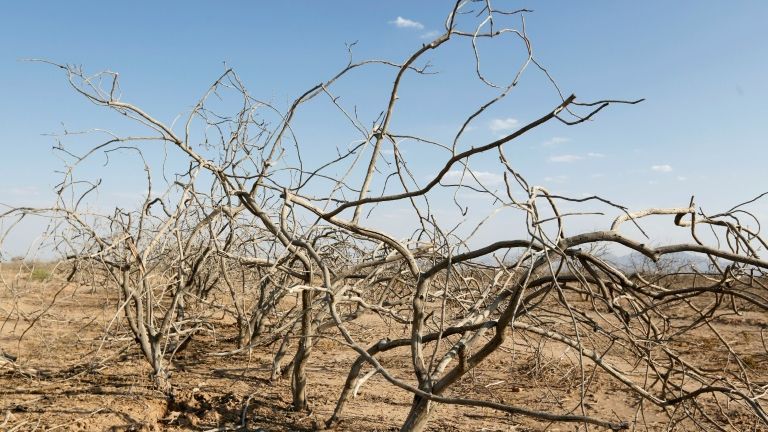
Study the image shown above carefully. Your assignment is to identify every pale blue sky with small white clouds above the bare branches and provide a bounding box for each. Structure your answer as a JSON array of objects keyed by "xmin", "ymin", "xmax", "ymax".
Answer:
[{"xmin": 0, "ymin": 0, "xmax": 768, "ymax": 253}]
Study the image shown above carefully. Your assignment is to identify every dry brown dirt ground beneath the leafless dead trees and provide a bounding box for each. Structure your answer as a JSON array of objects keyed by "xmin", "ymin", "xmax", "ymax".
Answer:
[{"xmin": 0, "ymin": 267, "xmax": 768, "ymax": 431}]
